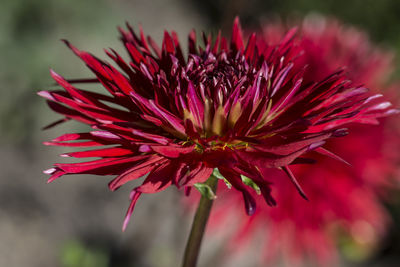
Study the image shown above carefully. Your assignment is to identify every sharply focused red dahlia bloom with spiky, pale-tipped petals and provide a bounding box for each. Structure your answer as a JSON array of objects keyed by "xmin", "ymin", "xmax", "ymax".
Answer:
[{"xmin": 39, "ymin": 20, "xmax": 394, "ymax": 229}]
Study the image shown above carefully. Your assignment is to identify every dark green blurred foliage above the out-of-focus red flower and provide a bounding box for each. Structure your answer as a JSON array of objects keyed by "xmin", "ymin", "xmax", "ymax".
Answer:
[{"xmin": 191, "ymin": 0, "xmax": 400, "ymax": 45}]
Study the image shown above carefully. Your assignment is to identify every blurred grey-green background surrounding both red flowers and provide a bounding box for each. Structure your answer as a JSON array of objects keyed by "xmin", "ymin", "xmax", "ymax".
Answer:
[{"xmin": 0, "ymin": 0, "xmax": 400, "ymax": 267}]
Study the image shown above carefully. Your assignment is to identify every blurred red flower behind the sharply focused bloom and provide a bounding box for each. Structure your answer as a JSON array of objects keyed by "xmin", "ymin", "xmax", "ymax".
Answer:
[{"xmin": 203, "ymin": 18, "xmax": 400, "ymax": 266}]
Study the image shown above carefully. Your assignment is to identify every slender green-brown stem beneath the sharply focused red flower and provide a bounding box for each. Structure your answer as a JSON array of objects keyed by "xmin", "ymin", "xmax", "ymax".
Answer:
[{"xmin": 182, "ymin": 175, "xmax": 218, "ymax": 267}]
